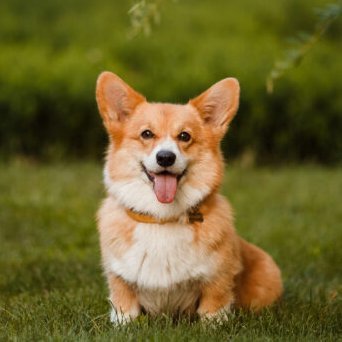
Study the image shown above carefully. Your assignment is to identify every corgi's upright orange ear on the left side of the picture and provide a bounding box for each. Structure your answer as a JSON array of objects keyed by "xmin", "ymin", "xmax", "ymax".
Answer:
[{"xmin": 96, "ymin": 71, "xmax": 146, "ymax": 130}]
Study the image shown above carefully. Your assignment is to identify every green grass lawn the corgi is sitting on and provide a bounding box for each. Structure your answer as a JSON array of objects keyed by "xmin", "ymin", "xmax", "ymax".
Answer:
[{"xmin": 0, "ymin": 162, "xmax": 342, "ymax": 342}]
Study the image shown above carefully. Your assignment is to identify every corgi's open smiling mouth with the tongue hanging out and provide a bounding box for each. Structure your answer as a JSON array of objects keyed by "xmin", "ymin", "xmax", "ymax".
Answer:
[{"xmin": 142, "ymin": 164, "xmax": 186, "ymax": 203}]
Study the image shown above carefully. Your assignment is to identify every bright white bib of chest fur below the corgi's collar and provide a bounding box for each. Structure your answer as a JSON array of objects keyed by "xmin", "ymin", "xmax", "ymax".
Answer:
[{"xmin": 111, "ymin": 223, "xmax": 215, "ymax": 290}]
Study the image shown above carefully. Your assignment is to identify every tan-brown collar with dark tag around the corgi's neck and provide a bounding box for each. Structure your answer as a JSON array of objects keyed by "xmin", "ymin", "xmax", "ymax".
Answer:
[{"xmin": 126, "ymin": 206, "xmax": 204, "ymax": 224}]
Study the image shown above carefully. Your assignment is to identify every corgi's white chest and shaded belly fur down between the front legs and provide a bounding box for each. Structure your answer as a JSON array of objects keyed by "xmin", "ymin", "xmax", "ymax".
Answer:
[{"xmin": 111, "ymin": 223, "xmax": 215, "ymax": 313}]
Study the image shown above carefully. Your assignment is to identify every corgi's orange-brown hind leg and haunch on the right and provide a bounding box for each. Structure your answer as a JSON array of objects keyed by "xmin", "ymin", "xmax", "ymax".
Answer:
[{"xmin": 235, "ymin": 239, "xmax": 283, "ymax": 310}]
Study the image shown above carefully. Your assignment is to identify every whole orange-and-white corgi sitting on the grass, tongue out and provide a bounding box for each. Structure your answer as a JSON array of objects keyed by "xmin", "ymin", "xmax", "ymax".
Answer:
[{"xmin": 96, "ymin": 72, "xmax": 282, "ymax": 324}]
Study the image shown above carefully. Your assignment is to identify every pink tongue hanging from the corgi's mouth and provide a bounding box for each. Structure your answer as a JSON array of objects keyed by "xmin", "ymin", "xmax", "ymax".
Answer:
[{"xmin": 153, "ymin": 174, "xmax": 177, "ymax": 203}]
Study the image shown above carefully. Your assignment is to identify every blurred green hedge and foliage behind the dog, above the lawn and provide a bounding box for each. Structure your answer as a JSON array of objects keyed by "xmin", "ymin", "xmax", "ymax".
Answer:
[{"xmin": 0, "ymin": 0, "xmax": 342, "ymax": 163}]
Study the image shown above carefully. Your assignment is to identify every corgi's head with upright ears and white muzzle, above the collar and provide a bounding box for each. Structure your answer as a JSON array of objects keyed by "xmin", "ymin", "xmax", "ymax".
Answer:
[{"xmin": 96, "ymin": 72, "xmax": 239, "ymax": 218}]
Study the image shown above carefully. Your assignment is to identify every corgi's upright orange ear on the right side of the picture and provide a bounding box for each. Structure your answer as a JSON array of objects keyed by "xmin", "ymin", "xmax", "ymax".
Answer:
[{"xmin": 189, "ymin": 78, "xmax": 240, "ymax": 133}]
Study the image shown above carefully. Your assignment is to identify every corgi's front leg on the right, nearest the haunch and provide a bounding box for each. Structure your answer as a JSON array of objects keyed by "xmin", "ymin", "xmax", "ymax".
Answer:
[{"xmin": 197, "ymin": 276, "xmax": 234, "ymax": 320}]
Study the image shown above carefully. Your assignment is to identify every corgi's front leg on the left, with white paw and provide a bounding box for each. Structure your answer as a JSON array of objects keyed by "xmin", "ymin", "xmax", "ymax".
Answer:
[{"xmin": 108, "ymin": 274, "xmax": 141, "ymax": 324}]
